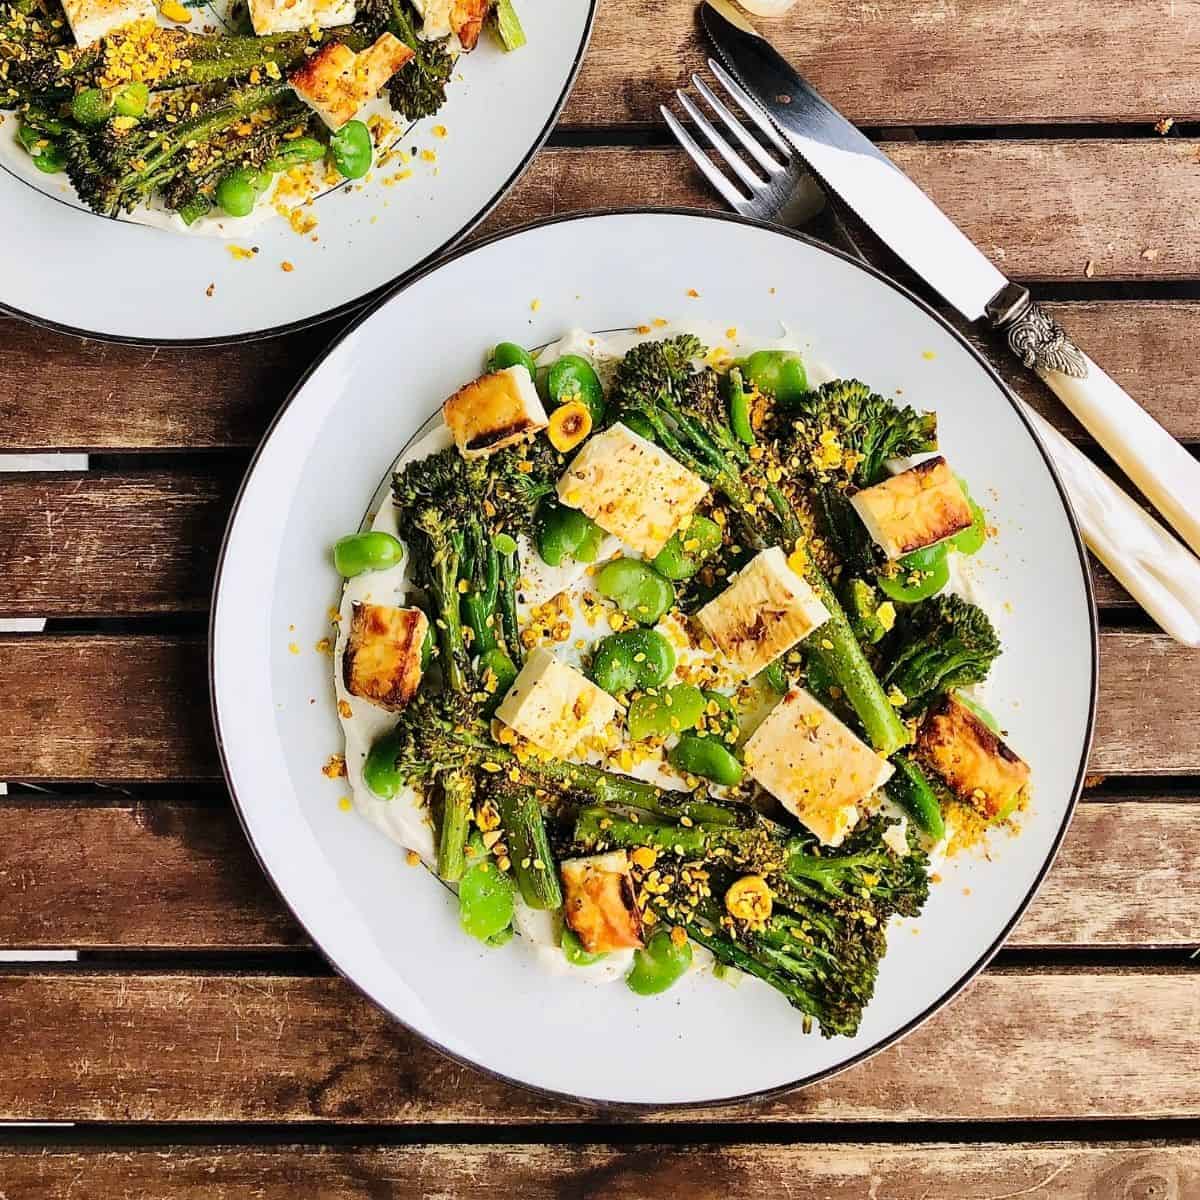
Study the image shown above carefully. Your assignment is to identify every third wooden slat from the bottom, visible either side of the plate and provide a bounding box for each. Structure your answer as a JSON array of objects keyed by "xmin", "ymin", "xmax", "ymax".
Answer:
[{"xmin": 0, "ymin": 797, "xmax": 1200, "ymax": 949}]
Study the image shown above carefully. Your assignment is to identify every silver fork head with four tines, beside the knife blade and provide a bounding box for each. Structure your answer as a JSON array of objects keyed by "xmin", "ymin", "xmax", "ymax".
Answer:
[{"xmin": 659, "ymin": 59, "xmax": 863, "ymax": 258}]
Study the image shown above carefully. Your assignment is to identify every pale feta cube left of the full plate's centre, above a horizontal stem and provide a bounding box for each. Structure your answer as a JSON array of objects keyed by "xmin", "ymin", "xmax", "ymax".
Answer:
[{"xmin": 496, "ymin": 646, "xmax": 620, "ymax": 758}]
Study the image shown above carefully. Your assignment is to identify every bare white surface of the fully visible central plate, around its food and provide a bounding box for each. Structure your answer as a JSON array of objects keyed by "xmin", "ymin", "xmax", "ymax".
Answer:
[{"xmin": 211, "ymin": 212, "xmax": 1096, "ymax": 1105}]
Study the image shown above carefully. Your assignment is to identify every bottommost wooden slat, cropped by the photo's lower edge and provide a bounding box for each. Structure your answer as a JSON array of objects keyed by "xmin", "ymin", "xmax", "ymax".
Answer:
[{"xmin": 0, "ymin": 1142, "xmax": 1200, "ymax": 1200}]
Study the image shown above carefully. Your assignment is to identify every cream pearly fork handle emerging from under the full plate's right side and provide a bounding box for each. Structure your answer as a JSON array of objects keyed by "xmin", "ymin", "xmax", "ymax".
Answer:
[{"xmin": 1022, "ymin": 403, "xmax": 1200, "ymax": 646}]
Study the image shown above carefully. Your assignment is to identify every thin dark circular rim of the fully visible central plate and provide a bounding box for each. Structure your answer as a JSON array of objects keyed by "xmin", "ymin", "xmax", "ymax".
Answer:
[{"xmin": 208, "ymin": 208, "xmax": 1099, "ymax": 1114}]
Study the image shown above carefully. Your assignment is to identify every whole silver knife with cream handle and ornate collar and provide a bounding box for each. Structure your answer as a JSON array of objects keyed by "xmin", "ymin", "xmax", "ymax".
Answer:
[{"xmin": 702, "ymin": 0, "xmax": 1200, "ymax": 576}]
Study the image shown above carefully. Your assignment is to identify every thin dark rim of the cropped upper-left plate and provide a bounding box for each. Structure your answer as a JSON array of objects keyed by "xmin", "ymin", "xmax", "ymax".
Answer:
[{"xmin": 0, "ymin": 0, "xmax": 599, "ymax": 358}]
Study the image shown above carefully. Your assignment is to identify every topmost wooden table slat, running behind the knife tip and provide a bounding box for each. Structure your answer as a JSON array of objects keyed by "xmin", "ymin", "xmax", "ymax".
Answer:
[{"xmin": 564, "ymin": 0, "xmax": 1200, "ymax": 125}]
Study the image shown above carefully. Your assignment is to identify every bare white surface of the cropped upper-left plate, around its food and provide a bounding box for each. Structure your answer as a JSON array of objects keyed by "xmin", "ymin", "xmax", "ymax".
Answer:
[{"xmin": 0, "ymin": 0, "xmax": 595, "ymax": 344}]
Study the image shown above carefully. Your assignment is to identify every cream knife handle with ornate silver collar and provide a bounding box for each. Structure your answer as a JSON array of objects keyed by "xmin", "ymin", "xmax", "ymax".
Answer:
[{"xmin": 1006, "ymin": 301, "xmax": 1200, "ymax": 554}]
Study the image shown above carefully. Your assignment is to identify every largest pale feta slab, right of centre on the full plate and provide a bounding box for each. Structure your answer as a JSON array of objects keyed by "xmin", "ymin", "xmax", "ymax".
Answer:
[{"xmin": 744, "ymin": 688, "xmax": 893, "ymax": 846}]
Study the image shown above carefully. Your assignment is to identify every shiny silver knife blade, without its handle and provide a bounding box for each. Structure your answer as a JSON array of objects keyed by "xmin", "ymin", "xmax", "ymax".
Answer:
[{"xmin": 702, "ymin": 0, "xmax": 1008, "ymax": 320}]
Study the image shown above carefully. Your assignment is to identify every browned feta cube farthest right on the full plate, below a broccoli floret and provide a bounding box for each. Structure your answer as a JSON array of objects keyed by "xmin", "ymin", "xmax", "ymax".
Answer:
[{"xmin": 917, "ymin": 692, "xmax": 1030, "ymax": 817}]
